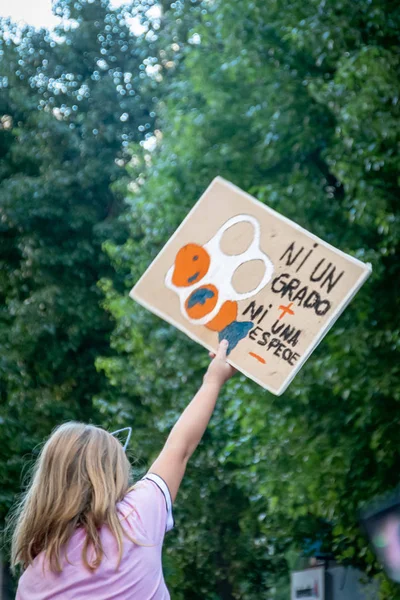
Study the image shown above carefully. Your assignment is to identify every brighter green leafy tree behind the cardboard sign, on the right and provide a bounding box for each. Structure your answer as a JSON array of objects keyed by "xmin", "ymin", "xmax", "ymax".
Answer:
[{"xmin": 98, "ymin": 0, "xmax": 400, "ymax": 599}]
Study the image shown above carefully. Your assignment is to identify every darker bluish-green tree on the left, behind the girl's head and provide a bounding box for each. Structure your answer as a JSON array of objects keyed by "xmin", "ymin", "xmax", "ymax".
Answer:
[{"xmin": 0, "ymin": 0, "xmax": 154, "ymax": 520}]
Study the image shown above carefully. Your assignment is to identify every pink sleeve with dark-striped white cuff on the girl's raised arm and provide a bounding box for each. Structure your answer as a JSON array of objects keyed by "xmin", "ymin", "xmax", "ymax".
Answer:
[{"xmin": 119, "ymin": 473, "xmax": 174, "ymax": 544}]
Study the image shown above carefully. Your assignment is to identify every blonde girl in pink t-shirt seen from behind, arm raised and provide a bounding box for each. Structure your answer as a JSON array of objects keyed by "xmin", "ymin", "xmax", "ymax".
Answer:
[{"xmin": 12, "ymin": 341, "xmax": 234, "ymax": 600}]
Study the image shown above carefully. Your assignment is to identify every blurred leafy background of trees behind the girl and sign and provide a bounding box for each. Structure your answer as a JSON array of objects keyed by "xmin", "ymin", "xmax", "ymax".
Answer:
[{"xmin": 0, "ymin": 0, "xmax": 400, "ymax": 600}]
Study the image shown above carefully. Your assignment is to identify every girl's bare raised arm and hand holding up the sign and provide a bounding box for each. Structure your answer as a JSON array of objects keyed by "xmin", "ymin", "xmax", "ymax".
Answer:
[{"xmin": 149, "ymin": 340, "xmax": 235, "ymax": 501}]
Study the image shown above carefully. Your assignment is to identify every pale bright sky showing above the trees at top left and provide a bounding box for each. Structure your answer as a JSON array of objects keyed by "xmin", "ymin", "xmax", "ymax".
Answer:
[{"xmin": 0, "ymin": 0, "xmax": 143, "ymax": 33}]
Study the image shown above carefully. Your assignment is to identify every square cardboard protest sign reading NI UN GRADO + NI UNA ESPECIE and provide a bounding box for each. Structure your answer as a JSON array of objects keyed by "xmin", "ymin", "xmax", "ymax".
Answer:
[{"xmin": 130, "ymin": 177, "xmax": 371, "ymax": 395}]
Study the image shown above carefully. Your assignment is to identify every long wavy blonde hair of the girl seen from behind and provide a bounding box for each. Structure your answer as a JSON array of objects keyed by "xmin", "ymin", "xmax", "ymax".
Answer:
[{"xmin": 11, "ymin": 422, "xmax": 134, "ymax": 573}]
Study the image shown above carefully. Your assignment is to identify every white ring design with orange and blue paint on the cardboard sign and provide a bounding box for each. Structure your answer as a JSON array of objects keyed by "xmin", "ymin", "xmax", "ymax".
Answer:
[{"xmin": 165, "ymin": 215, "xmax": 274, "ymax": 354}]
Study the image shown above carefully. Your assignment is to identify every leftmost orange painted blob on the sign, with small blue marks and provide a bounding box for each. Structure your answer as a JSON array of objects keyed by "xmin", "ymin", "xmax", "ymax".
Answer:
[{"xmin": 172, "ymin": 244, "xmax": 210, "ymax": 287}]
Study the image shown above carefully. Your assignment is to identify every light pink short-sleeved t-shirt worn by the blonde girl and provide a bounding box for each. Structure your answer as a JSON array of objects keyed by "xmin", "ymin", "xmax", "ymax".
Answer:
[{"xmin": 16, "ymin": 474, "xmax": 173, "ymax": 600}]
